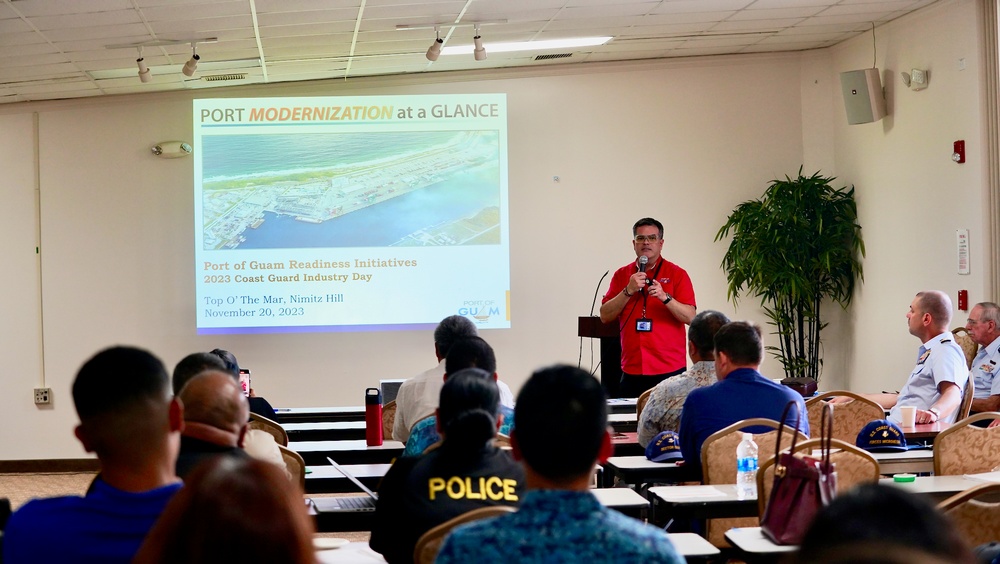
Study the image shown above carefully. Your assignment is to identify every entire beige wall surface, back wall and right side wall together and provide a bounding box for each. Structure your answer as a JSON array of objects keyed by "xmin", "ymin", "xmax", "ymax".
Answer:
[{"xmin": 0, "ymin": 0, "xmax": 982, "ymax": 459}]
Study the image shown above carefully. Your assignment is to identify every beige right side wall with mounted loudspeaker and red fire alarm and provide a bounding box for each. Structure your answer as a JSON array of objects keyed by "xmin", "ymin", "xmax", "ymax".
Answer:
[{"xmin": 824, "ymin": 1, "xmax": 996, "ymax": 392}]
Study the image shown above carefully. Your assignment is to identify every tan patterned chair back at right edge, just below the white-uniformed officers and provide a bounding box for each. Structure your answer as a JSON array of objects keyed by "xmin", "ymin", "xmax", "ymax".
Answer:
[{"xmin": 934, "ymin": 411, "xmax": 1000, "ymax": 476}]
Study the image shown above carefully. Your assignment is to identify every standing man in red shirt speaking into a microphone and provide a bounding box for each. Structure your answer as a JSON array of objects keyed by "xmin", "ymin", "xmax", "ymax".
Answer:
[{"xmin": 601, "ymin": 217, "xmax": 697, "ymax": 398}]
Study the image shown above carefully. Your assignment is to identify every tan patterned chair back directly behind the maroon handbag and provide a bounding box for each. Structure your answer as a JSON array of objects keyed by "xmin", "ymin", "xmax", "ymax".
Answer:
[{"xmin": 757, "ymin": 438, "xmax": 879, "ymax": 515}]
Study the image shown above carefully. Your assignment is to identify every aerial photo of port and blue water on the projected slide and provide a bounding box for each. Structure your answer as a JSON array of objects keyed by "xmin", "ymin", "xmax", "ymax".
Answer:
[{"xmin": 201, "ymin": 131, "xmax": 501, "ymax": 250}]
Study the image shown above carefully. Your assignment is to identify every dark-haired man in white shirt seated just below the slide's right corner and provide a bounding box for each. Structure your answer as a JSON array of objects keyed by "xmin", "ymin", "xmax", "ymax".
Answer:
[{"xmin": 392, "ymin": 315, "xmax": 514, "ymax": 443}]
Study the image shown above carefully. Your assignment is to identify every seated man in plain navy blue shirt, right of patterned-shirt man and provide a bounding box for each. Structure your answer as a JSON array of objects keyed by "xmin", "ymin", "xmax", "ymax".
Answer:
[{"xmin": 679, "ymin": 321, "xmax": 809, "ymax": 473}]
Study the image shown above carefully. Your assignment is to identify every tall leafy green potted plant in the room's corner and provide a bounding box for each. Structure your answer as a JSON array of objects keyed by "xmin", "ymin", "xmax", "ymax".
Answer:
[{"xmin": 715, "ymin": 167, "xmax": 865, "ymax": 382}]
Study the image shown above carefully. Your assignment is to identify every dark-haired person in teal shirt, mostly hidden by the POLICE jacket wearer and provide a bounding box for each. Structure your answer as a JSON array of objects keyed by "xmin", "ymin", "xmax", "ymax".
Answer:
[{"xmin": 403, "ymin": 337, "xmax": 514, "ymax": 456}]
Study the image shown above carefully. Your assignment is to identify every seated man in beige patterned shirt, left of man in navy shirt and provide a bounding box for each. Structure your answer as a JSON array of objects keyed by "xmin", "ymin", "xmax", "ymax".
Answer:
[{"xmin": 639, "ymin": 310, "xmax": 729, "ymax": 447}]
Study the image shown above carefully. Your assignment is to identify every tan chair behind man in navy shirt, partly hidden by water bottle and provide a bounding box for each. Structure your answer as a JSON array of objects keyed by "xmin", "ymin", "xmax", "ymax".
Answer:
[{"xmin": 701, "ymin": 417, "xmax": 806, "ymax": 548}]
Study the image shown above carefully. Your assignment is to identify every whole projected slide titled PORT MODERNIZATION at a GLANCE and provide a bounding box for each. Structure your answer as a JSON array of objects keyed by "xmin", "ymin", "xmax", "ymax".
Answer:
[{"xmin": 193, "ymin": 94, "xmax": 510, "ymax": 334}]
